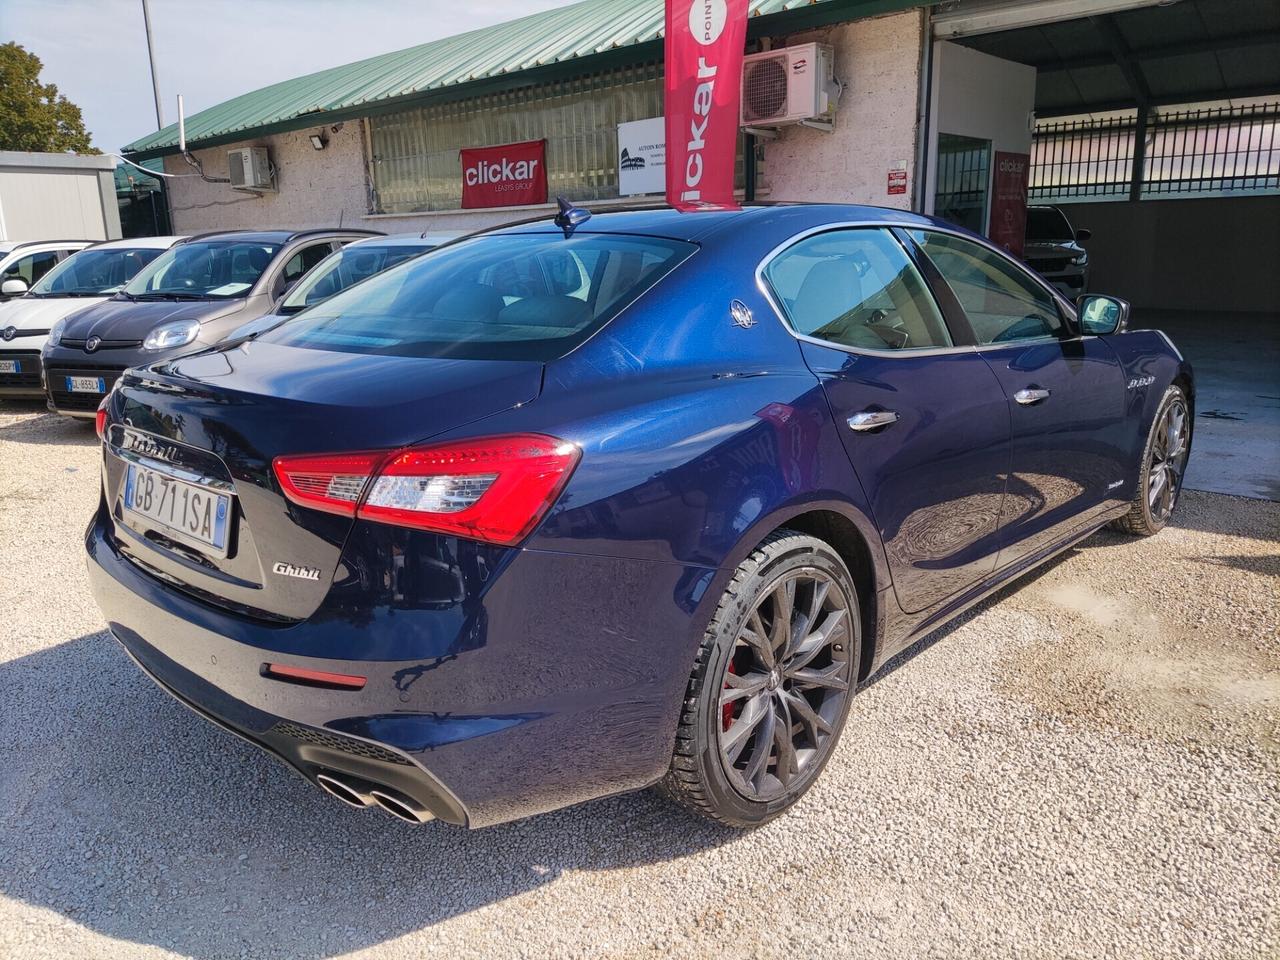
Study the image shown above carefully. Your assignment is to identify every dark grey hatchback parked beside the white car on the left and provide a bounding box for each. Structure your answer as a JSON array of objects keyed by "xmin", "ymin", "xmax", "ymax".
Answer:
[{"xmin": 42, "ymin": 229, "xmax": 378, "ymax": 417}]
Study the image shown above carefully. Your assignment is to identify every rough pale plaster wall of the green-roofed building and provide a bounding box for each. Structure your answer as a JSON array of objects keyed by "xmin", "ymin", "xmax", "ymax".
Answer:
[{"xmin": 165, "ymin": 10, "xmax": 927, "ymax": 234}]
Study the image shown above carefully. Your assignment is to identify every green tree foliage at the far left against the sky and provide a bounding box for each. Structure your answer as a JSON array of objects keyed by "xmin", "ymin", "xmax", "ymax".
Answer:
[{"xmin": 0, "ymin": 42, "xmax": 99, "ymax": 154}]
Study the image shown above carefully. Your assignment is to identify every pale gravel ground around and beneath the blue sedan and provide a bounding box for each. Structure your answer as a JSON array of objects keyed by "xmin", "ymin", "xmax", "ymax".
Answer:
[{"xmin": 0, "ymin": 403, "xmax": 1280, "ymax": 960}]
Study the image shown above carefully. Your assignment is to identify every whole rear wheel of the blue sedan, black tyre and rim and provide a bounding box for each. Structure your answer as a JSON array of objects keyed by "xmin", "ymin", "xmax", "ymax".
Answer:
[{"xmin": 659, "ymin": 530, "xmax": 861, "ymax": 827}]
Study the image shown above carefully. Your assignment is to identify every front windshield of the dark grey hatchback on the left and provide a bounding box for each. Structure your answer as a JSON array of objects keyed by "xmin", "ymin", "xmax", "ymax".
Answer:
[{"xmin": 124, "ymin": 239, "xmax": 280, "ymax": 300}]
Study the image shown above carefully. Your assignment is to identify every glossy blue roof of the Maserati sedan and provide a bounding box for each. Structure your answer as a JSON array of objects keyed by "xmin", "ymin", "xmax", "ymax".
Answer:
[{"xmin": 494, "ymin": 204, "xmax": 941, "ymax": 241}]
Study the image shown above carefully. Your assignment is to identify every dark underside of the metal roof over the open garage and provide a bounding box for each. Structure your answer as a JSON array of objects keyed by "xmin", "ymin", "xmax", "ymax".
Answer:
[{"xmin": 934, "ymin": 0, "xmax": 1280, "ymax": 118}]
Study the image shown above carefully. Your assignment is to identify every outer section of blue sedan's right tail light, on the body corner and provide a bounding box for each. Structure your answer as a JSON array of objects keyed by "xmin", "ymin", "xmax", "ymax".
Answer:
[{"xmin": 357, "ymin": 434, "xmax": 581, "ymax": 547}]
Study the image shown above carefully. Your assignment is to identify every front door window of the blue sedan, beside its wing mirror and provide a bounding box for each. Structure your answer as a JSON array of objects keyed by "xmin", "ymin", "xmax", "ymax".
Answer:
[{"xmin": 911, "ymin": 230, "xmax": 1066, "ymax": 344}]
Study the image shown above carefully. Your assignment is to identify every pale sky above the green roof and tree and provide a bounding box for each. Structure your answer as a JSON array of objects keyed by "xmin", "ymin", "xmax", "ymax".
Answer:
[{"xmin": 0, "ymin": 0, "xmax": 570, "ymax": 152}]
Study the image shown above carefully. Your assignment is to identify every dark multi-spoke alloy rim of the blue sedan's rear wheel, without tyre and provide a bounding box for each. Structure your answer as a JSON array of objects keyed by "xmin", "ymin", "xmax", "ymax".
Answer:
[{"xmin": 718, "ymin": 568, "xmax": 852, "ymax": 801}]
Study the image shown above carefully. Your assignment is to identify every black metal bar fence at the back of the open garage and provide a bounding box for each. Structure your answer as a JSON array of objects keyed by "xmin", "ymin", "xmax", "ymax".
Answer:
[{"xmin": 1030, "ymin": 101, "xmax": 1280, "ymax": 201}]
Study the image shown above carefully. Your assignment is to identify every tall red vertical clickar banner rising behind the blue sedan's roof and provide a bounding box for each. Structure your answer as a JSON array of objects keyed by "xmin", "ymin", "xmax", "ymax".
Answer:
[{"xmin": 664, "ymin": 0, "xmax": 748, "ymax": 211}]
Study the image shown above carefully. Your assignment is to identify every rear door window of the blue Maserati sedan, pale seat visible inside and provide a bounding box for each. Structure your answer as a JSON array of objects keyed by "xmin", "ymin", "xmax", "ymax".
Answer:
[{"xmin": 764, "ymin": 229, "xmax": 951, "ymax": 349}]
